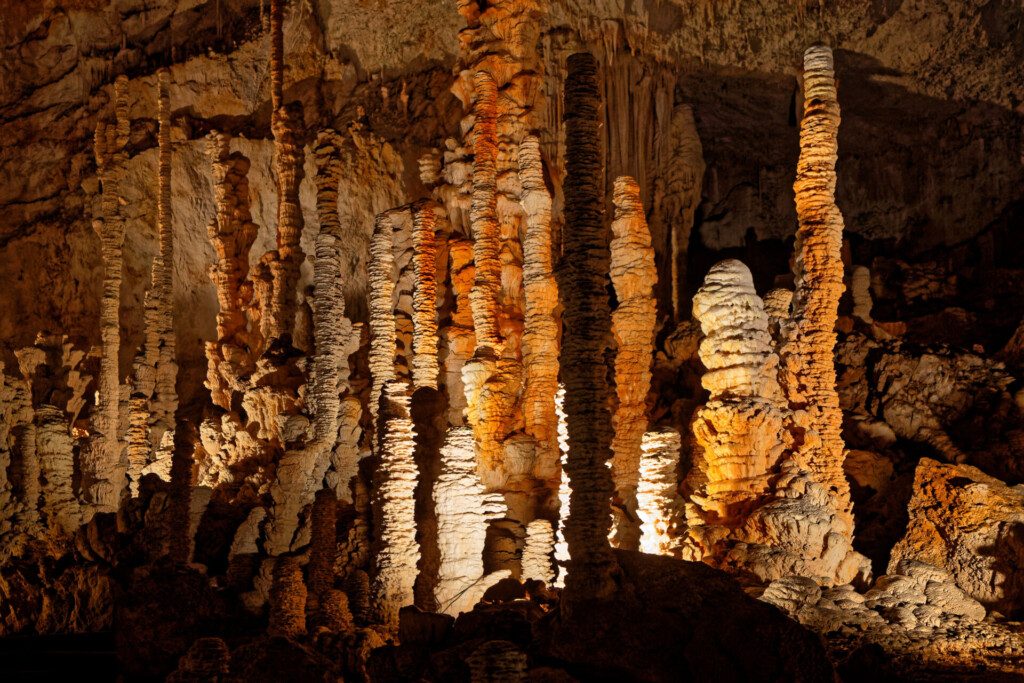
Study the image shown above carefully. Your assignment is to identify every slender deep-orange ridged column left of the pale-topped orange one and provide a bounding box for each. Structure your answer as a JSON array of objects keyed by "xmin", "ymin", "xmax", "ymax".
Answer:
[{"xmin": 469, "ymin": 72, "xmax": 501, "ymax": 352}]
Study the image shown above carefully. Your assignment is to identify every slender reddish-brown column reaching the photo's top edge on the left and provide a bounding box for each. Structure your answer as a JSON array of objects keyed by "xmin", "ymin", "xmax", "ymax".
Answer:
[{"xmin": 263, "ymin": 0, "xmax": 305, "ymax": 339}]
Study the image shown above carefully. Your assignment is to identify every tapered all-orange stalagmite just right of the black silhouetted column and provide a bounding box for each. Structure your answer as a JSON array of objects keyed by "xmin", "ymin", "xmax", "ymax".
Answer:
[{"xmin": 610, "ymin": 176, "xmax": 657, "ymax": 550}]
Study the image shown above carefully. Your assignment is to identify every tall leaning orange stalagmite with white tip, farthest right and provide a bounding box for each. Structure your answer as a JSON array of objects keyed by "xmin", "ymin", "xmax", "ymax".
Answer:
[{"xmin": 780, "ymin": 46, "xmax": 853, "ymax": 539}]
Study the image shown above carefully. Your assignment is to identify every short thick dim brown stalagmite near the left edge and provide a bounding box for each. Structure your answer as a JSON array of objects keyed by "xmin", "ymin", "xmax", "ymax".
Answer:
[{"xmin": 36, "ymin": 405, "xmax": 81, "ymax": 533}]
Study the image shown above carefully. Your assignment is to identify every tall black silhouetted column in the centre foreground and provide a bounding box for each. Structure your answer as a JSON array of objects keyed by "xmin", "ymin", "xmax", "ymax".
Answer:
[{"xmin": 558, "ymin": 52, "xmax": 617, "ymax": 601}]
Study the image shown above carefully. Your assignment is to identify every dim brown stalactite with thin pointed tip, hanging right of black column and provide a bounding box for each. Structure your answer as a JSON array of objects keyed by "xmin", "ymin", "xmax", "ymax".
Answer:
[{"xmin": 665, "ymin": 104, "xmax": 706, "ymax": 321}]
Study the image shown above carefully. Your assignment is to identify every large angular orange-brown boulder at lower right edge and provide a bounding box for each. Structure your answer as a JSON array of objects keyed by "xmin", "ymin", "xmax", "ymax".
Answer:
[{"xmin": 889, "ymin": 458, "xmax": 1024, "ymax": 614}]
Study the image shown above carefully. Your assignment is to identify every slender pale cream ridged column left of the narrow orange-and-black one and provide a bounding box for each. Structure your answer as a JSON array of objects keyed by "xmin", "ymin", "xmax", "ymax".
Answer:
[{"xmin": 368, "ymin": 213, "xmax": 397, "ymax": 429}]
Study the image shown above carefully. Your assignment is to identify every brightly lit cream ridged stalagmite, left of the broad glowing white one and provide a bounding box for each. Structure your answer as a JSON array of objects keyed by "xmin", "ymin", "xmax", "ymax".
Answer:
[{"xmin": 371, "ymin": 381, "xmax": 420, "ymax": 627}]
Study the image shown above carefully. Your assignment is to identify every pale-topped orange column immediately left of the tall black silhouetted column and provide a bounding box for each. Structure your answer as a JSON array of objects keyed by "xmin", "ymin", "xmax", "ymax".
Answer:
[{"xmin": 519, "ymin": 135, "xmax": 560, "ymax": 485}]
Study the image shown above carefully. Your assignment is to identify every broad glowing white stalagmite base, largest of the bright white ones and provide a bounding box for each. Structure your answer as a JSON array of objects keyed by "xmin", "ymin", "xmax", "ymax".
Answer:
[{"xmin": 433, "ymin": 427, "xmax": 509, "ymax": 615}]
